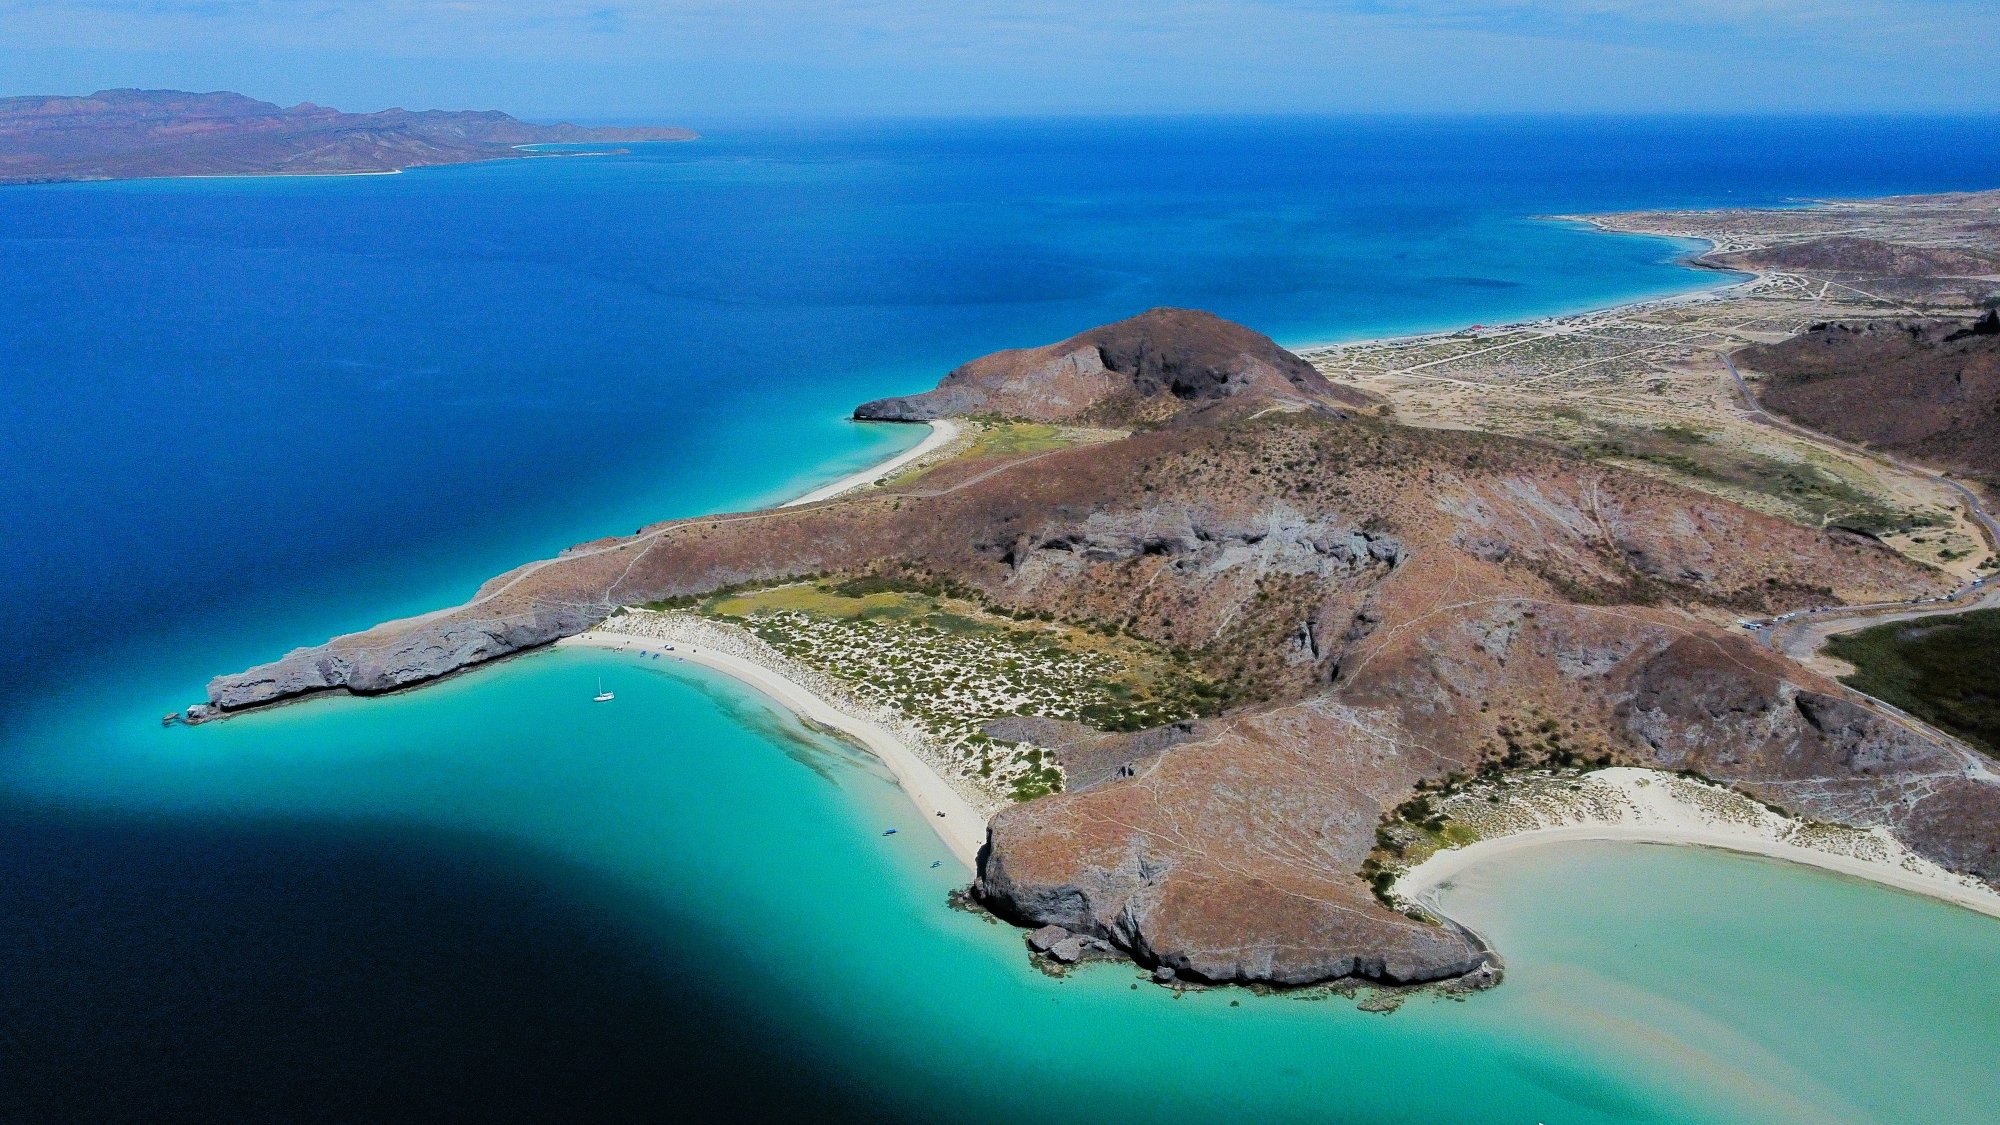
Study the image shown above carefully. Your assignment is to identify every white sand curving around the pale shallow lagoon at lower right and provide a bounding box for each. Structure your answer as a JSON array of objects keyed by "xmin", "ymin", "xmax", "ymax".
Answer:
[{"xmin": 1394, "ymin": 767, "xmax": 2000, "ymax": 919}]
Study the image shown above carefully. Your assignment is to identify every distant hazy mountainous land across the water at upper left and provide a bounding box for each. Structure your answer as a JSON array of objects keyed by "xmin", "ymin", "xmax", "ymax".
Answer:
[{"xmin": 0, "ymin": 90, "xmax": 696, "ymax": 184}]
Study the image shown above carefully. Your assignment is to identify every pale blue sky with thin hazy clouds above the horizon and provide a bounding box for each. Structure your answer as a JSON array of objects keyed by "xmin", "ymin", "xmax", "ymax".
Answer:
[{"xmin": 0, "ymin": 0, "xmax": 2000, "ymax": 126}]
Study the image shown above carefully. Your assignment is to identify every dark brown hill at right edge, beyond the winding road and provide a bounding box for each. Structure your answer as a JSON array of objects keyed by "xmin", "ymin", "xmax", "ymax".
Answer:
[{"xmin": 1734, "ymin": 314, "xmax": 2000, "ymax": 486}]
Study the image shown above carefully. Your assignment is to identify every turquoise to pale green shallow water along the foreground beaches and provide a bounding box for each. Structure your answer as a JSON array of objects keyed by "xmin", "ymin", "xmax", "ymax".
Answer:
[{"xmin": 6, "ymin": 651, "xmax": 2000, "ymax": 1125}]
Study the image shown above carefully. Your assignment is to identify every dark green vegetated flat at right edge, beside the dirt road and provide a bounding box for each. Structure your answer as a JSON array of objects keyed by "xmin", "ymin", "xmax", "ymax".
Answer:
[{"xmin": 1826, "ymin": 609, "xmax": 2000, "ymax": 757}]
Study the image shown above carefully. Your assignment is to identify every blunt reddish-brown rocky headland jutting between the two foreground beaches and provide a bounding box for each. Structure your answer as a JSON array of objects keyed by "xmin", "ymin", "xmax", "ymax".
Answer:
[{"xmin": 978, "ymin": 703, "xmax": 1488, "ymax": 985}]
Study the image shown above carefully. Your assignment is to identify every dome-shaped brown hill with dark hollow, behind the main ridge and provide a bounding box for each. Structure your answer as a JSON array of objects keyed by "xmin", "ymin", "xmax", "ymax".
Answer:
[{"xmin": 854, "ymin": 308, "xmax": 1376, "ymax": 424}]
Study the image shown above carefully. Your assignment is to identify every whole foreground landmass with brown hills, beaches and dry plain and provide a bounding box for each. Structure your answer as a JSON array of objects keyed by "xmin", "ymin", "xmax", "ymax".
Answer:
[{"xmin": 190, "ymin": 194, "xmax": 2000, "ymax": 985}]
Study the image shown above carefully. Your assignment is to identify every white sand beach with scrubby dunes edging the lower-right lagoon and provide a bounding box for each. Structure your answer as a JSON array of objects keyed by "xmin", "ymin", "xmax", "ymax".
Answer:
[{"xmin": 1394, "ymin": 767, "xmax": 2000, "ymax": 917}]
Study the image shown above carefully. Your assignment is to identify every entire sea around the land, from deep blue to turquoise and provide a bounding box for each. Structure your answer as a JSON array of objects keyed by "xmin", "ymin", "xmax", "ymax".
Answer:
[{"xmin": 11, "ymin": 118, "xmax": 2000, "ymax": 1125}]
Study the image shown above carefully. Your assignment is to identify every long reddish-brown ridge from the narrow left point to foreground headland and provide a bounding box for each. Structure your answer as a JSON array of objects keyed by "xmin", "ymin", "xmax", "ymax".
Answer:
[{"xmin": 199, "ymin": 310, "xmax": 2000, "ymax": 985}]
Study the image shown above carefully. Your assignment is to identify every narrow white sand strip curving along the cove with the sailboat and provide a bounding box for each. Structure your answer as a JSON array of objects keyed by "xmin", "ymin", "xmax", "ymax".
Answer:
[{"xmin": 556, "ymin": 633, "xmax": 986, "ymax": 873}]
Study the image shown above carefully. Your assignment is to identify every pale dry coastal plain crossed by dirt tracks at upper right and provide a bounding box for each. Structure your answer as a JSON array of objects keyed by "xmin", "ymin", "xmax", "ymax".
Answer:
[{"xmin": 1306, "ymin": 192, "xmax": 2000, "ymax": 579}]
